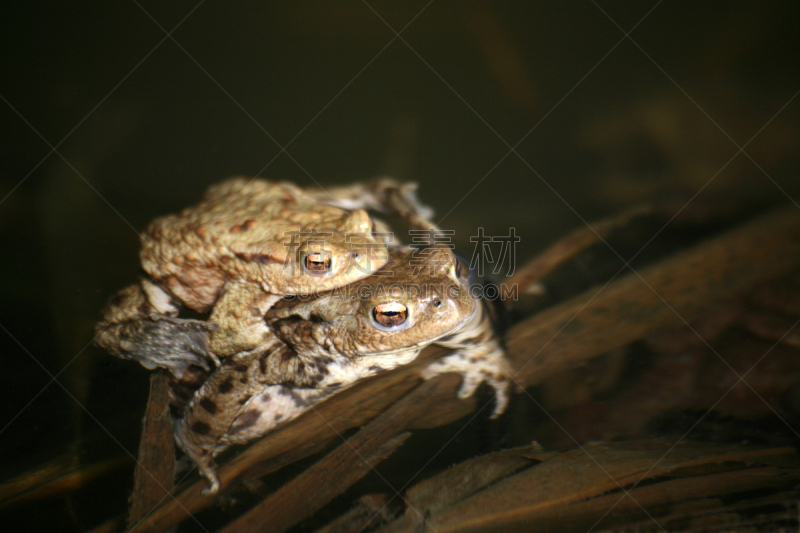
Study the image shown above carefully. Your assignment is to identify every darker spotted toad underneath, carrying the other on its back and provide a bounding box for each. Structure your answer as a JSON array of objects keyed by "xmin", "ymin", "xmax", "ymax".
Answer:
[{"xmin": 175, "ymin": 246, "xmax": 508, "ymax": 493}]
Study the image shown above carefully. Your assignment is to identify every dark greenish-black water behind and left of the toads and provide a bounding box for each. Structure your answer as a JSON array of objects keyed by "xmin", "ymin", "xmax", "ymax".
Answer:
[{"xmin": 0, "ymin": 1, "xmax": 800, "ymax": 531}]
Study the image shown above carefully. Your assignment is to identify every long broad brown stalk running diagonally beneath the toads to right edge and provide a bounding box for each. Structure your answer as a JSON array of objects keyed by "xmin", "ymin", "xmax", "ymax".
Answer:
[{"xmin": 128, "ymin": 206, "xmax": 800, "ymax": 531}]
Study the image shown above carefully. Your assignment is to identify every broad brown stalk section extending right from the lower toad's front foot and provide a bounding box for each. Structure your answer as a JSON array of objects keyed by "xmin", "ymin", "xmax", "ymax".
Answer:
[{"xmin": 507, "ymin": 206, "xmax": 800, "ymax": 386}]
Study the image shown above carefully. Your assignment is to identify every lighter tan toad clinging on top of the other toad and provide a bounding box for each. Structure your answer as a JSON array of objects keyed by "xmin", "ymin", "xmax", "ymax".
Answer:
[{"xmin": 96, "ymin": 178, "xmax": 434, "ymax": 376}]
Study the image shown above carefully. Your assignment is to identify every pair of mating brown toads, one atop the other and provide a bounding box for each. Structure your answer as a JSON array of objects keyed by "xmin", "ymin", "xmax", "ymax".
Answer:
[{"xmin": 96, "ymin": 178, "xmax": 509, "ymax": 494}]
